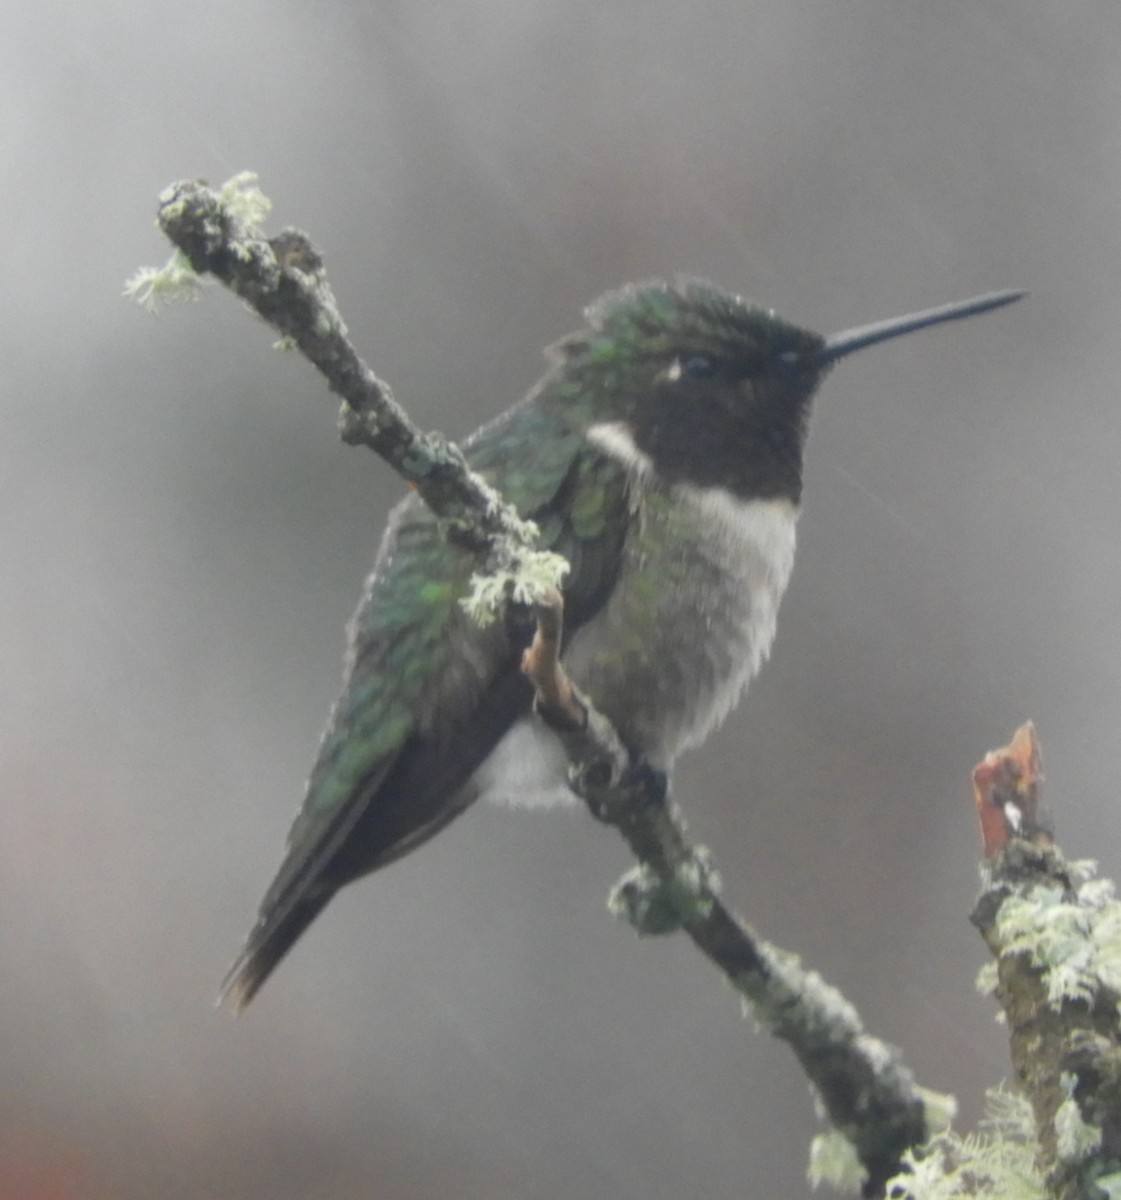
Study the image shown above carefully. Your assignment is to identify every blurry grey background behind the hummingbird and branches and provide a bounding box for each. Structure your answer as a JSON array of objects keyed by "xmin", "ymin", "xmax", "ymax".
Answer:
[{"xmin": 0, "ymin": 0, "xmax": 1121, "ymax": 1200}]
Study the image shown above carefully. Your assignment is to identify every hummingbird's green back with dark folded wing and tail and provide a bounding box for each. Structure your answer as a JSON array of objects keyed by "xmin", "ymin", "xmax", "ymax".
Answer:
[{"xmin": 223, "ymin": 404, "xmax": 628, "ymax": 1008}]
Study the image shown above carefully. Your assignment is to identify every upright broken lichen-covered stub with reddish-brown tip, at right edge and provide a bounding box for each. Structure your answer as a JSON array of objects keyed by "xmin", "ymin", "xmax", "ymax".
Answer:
[{"xmin": 972, "ymin": 725, "xmax": 1121, "ymax": 1200}]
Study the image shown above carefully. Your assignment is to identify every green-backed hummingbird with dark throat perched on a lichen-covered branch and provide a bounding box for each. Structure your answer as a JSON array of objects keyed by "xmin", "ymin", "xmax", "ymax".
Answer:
[{"xmin": 222, "ymin": 280, "xmax": 1024, "ymax": 1010}]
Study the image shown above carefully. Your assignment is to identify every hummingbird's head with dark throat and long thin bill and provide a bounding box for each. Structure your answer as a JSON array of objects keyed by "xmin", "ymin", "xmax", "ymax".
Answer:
[{"xmin": 540, "ymin": 280, "xmax": 1024, "ymax": 503}]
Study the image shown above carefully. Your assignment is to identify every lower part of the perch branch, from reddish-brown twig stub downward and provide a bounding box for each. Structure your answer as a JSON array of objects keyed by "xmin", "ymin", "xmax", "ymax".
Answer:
[{"xmin": 523, "ymin": 595, "xmax": 935, "ymax": 1195}]
